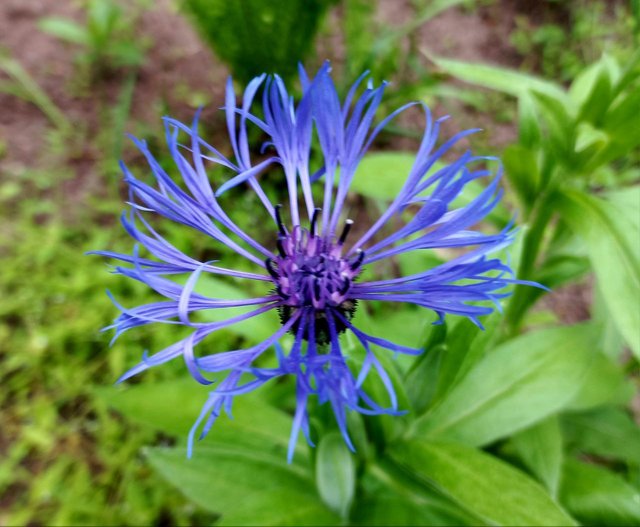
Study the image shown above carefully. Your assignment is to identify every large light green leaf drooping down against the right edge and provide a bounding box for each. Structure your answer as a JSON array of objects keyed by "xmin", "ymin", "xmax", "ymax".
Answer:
[{"xmin": 560, "ymin": 189, "xmax": 640, "ymax": 358}]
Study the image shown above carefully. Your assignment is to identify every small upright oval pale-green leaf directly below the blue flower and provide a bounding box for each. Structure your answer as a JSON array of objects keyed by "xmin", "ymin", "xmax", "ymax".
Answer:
[{"xmin": 316, "ymin": 432, "xmax": 356, "ymax": 518}]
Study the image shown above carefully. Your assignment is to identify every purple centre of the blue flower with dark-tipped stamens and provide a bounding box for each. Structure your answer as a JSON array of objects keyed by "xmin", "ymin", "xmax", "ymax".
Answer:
[{"xmin": 266, "ymin": 206, "xmax": 364, "ymax": 342}]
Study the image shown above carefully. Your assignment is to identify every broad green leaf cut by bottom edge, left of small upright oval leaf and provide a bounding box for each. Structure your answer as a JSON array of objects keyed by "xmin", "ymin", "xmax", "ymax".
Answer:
[{"xmin": 147, "ymin": 445, "xmax": 339, "ymax": 525}]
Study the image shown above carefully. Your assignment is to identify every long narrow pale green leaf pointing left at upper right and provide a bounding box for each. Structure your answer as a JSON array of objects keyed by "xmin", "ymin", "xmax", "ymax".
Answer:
[{"xmin": 430, "ymin": 57, "xmax": 568, "ymax": 102}]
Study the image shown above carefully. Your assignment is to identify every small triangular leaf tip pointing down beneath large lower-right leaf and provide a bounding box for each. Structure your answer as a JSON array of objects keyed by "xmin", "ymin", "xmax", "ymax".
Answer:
[{"xmin": 511, "ymin": 416, "xmax": 564, "ymax": 497}]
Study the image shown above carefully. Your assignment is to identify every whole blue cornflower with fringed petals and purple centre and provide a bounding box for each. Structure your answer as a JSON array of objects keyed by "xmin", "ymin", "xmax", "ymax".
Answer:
[{"xmin": 98, "ymin": 65, "xmax": 536, "ymax": 458}]
